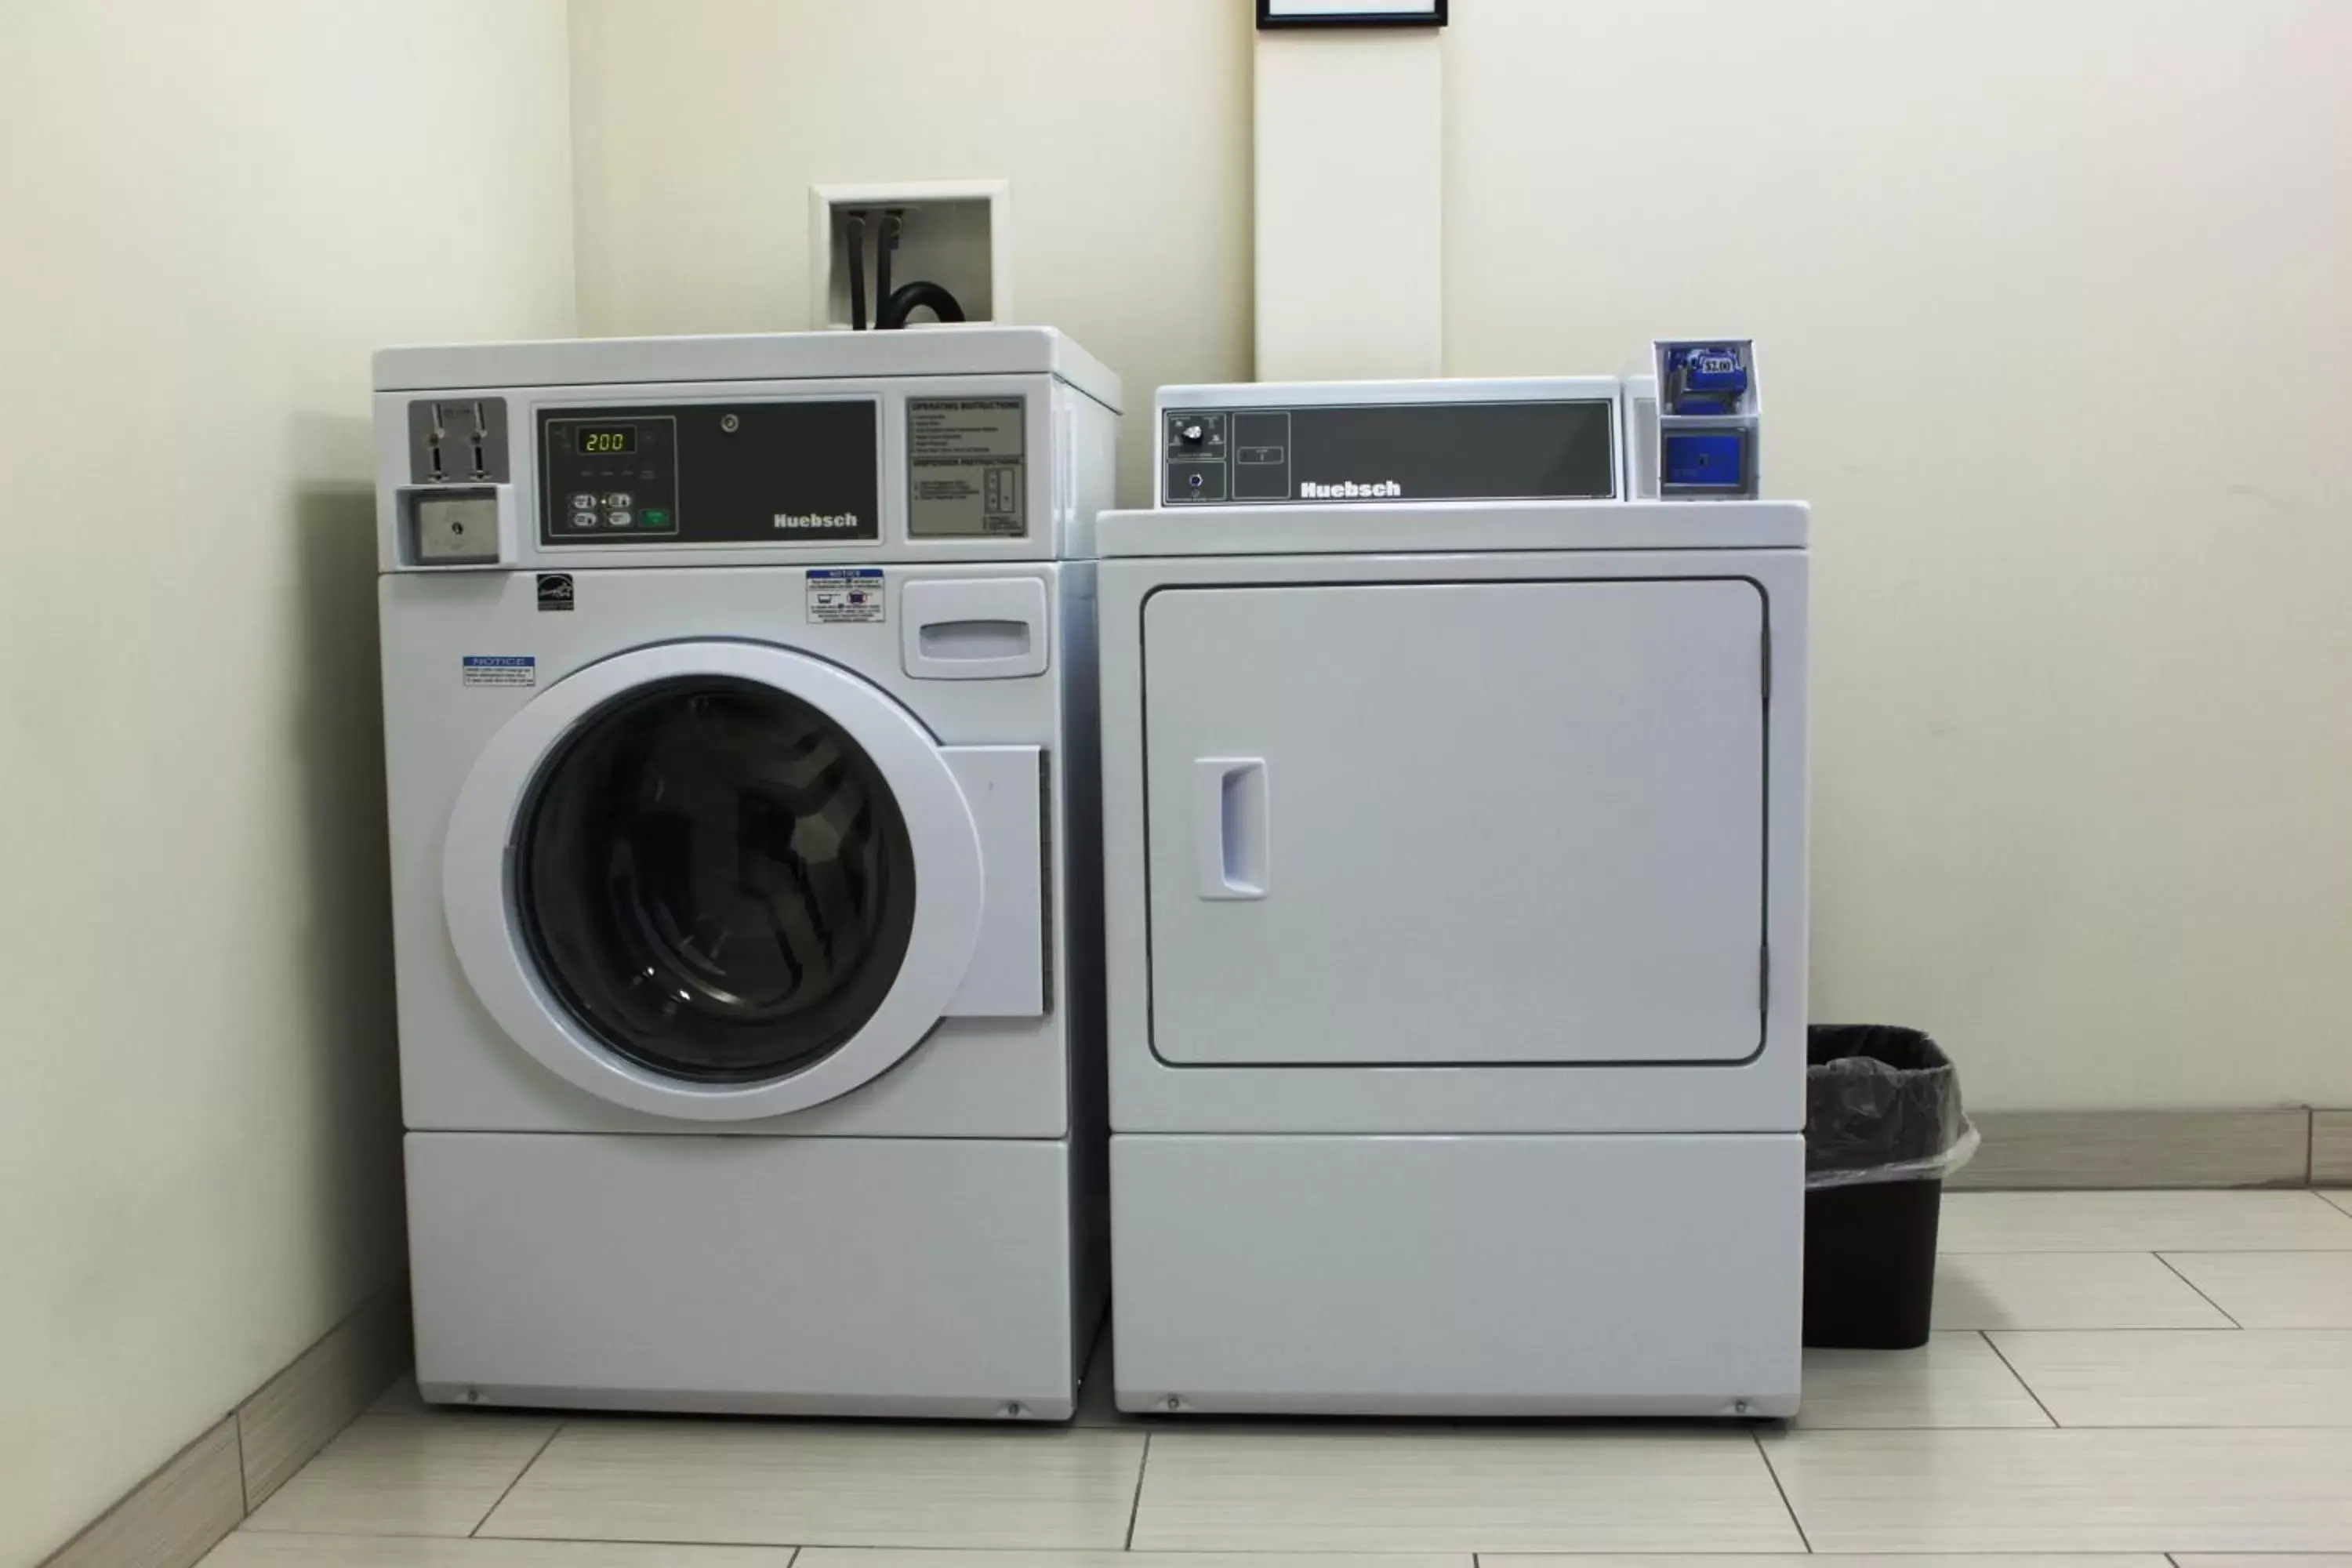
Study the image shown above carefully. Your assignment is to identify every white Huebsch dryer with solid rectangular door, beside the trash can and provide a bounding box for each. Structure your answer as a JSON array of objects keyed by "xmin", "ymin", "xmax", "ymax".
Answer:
[{"xmin": 1098, "ymin": 379, "xmax": 1806, "ymax": 1415}]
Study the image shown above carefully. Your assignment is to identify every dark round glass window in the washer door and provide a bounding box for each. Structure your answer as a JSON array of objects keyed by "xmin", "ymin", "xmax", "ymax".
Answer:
[{"xmin": 515, "ymin": 677, "xmax": 915, "ymax": 1083}]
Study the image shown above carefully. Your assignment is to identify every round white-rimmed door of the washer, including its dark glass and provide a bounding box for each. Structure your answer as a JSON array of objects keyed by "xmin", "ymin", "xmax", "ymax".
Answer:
[{"xmin": 442, "ymin": 642, "xmax": 983, "ymax": 1121}]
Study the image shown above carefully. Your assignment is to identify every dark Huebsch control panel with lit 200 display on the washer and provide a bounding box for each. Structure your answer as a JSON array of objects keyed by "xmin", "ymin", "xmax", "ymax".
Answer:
[{"xmin": 536, "ymin": 397, "xmax": 882, "ymax": 546}]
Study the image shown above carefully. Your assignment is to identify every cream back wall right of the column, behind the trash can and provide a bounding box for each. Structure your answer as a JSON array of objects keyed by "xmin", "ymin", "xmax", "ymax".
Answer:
[{"xmin": 1446, "ymin": 0, "xmax": 2352, "ymax": 1107}]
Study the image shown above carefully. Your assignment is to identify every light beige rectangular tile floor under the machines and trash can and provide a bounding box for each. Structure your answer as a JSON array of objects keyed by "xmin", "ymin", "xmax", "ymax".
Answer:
[{"xmin": 205, "ymin": 1192, "xmax": 2352, "ymax": 1568}]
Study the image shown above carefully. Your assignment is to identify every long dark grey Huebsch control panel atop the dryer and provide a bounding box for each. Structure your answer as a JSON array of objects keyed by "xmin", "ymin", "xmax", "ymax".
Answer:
[{"xmin": 1160, "ymin": 383, "xmax": 1618, "ymax": 506}]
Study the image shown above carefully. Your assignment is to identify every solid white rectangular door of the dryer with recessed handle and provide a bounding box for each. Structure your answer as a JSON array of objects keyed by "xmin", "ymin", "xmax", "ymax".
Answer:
[{"xmin": 1143, "ymin": 579, "xmax": 1766, "ymax": 1067}]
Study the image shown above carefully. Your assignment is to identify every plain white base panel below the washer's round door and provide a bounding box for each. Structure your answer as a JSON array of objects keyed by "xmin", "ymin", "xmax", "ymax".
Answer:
[{"xmin": 407, "ymin": 1133, "xmax": 1101, "ymax": 1420}]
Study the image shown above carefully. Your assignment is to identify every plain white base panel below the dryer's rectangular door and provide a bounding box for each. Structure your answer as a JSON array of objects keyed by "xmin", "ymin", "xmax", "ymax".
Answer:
[{"xmin": 1110, "ymin": 1133, "xmax": 1804, "ymax": 1415}]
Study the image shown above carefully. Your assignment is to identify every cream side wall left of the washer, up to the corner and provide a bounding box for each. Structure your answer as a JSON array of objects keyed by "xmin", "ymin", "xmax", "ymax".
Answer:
[{"xmin": 0, "ymin": 0, "xmax": 574, "ymax": 1563}]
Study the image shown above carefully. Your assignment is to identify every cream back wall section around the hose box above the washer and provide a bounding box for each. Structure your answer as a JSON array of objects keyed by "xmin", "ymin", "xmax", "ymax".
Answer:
[{"xmin": 572, "ymin": 0, "xmax": 1251, "ymax": 503}]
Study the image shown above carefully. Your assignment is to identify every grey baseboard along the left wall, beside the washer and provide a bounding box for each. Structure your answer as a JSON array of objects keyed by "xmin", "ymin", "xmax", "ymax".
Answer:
[{"xmin": 42, "ymin": 1279, "xmax": 409, "ymax": 1568}]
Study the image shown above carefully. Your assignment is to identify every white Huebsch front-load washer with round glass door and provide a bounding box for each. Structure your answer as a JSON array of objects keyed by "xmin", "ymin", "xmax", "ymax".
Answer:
[{"xmin": 376, "ymin": 329, "xmax": 1120, "ymax": 1420}]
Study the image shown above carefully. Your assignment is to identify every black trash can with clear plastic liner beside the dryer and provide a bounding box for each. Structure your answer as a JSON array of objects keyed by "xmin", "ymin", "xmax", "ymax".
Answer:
[{"xmin": 1804, "ymin": 1022, "xmax": 1976, "ymax": 1349}]
